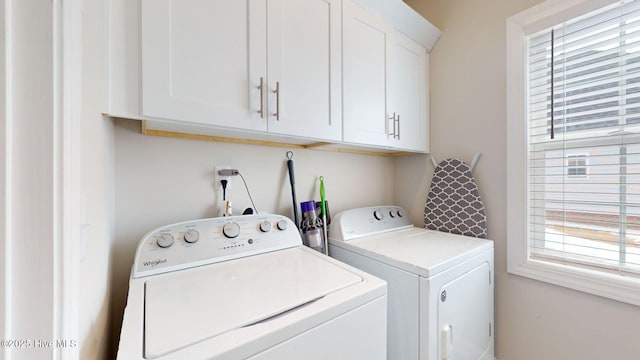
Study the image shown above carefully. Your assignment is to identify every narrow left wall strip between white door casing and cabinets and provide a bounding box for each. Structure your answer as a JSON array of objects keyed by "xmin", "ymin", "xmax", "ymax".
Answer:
[{"xmin": 78, "ymin": 0, "xmax": 115, "ymax": 359}]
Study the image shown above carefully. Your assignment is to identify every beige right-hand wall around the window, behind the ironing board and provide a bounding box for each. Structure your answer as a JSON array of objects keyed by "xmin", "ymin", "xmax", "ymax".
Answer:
[{"xmin": 395, "ymin": 0, "xmax": 640, "ymax": 360}]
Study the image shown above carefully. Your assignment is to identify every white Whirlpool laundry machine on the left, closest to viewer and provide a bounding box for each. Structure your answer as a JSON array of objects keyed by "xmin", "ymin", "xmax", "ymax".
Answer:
[{"xmin": 118, "ymin": 214, "xmax": 387, "ymax": 360}]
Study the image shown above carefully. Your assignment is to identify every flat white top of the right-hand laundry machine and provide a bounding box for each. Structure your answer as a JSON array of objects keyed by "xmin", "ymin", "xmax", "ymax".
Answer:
[{"xmin": 331, "ymin": 227, "xmax": 493, "ymax": 278}]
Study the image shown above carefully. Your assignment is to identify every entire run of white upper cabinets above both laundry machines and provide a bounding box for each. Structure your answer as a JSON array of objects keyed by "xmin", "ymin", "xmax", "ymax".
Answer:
[{"xmin": 106, "ymin": 0, "xmax": 440, "ymax": 152}]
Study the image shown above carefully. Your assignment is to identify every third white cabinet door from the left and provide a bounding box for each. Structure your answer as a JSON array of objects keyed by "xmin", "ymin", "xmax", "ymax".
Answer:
[{"xmin": 343, "ymin": 0, "xmax": 393, "ymax": 146}]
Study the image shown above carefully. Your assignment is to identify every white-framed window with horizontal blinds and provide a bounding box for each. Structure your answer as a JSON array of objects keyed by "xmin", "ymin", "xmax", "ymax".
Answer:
[{"xmin": 507, "ymin": 0, "xmax": 640, "ymax": 305}]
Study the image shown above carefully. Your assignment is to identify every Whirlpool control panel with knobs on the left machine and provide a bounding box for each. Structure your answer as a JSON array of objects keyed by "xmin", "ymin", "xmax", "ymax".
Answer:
[{"xmin": 131, "ymin": 214, "xmax": 302, "ymax": 278}]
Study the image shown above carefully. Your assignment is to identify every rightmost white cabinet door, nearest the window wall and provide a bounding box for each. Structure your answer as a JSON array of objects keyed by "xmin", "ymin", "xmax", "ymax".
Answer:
[{"xmin": 389, "ymin": 32, "xmax": 429, "ymax": 152}]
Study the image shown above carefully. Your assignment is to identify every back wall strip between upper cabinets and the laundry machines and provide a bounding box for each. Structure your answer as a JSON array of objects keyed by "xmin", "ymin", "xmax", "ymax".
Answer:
[{"xmin": 112, "ymin": 120, "xmax": 394, "ymax": 352}]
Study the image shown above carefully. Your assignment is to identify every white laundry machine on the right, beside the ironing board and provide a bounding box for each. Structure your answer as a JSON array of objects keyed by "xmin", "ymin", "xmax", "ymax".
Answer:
[{"xmin": 329, "ymin": 206, "xmax": 494, "ymax": 360}]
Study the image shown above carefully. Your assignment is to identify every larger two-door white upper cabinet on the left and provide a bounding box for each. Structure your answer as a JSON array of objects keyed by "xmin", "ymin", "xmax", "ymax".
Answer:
[{"xmin": 141, "ymin": 0, "xmax": 342, "ymax": 141}]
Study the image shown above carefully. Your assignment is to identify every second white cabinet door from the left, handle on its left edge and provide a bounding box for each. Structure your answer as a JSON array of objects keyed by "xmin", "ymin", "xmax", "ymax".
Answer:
[{"xmin": 267, "ymin": 0, "xmax": 342, "ymax": 140}]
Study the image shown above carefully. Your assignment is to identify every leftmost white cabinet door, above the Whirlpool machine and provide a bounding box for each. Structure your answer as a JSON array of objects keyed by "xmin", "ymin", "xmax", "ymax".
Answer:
[{"xmin": 141, "ymin": 0, "xmax": 267, "ymax": 131}]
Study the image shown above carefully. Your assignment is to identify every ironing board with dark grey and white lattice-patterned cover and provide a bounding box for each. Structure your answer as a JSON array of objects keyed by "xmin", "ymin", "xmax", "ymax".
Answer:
[{"xmin": 424, "ymin": 159, "xmax": 487, "ymax": 238}]
